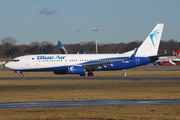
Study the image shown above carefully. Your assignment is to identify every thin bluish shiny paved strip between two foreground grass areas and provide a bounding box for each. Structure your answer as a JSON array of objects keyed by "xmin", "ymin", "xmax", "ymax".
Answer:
[{"xmin": 0, "ymin": 100, "xmax": 180, "ymax": 108}]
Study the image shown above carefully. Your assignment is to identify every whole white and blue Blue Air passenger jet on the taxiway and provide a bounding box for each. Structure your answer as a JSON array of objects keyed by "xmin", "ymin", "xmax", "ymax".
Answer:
[{"xmin": 5, "ymin": 23, "xmax": 164, "ymax": 76}]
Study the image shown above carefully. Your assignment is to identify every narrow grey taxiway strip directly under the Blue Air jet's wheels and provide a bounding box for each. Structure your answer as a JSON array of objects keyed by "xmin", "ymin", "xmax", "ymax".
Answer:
[{"xmin": 0, "ymin": 76, "xmax": 180, "ymax": 80}]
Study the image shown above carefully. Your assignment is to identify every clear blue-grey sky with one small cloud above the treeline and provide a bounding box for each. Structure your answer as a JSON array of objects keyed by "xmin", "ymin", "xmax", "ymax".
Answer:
[{"xmin": 0, "ymin": 0, "xmax": 180, "ymax": 45}]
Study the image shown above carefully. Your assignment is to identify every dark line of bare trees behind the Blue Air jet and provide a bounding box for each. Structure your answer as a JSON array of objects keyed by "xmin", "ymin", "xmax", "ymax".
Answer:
[{"xmin": 0, "ymin": 37, "xmax": 180, "ymax": 58}]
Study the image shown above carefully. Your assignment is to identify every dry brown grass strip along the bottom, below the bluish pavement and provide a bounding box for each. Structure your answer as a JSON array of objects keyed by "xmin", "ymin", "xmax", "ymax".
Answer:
[{"xmin": 0, "ymin": 105, "xmax": 180, "ymax": 120}]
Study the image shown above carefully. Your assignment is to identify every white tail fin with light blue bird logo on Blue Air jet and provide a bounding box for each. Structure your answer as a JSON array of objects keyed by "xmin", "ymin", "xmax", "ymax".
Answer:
[{"xmin": 137, "ymin": 23, "xmax": 164, "ymax": 56}]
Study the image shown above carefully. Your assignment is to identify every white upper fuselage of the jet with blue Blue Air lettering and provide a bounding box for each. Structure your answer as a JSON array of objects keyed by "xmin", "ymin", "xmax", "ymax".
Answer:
[{"xmin": 6, "ymin": 54, "xmax": 147, "ymax": 70}]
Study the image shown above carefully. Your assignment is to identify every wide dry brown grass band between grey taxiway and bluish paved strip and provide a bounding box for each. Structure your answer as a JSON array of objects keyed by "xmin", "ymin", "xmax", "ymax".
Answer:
[{"xmin": 0, "ymin": 80, "xmax": 180, "ymax": 102}]
